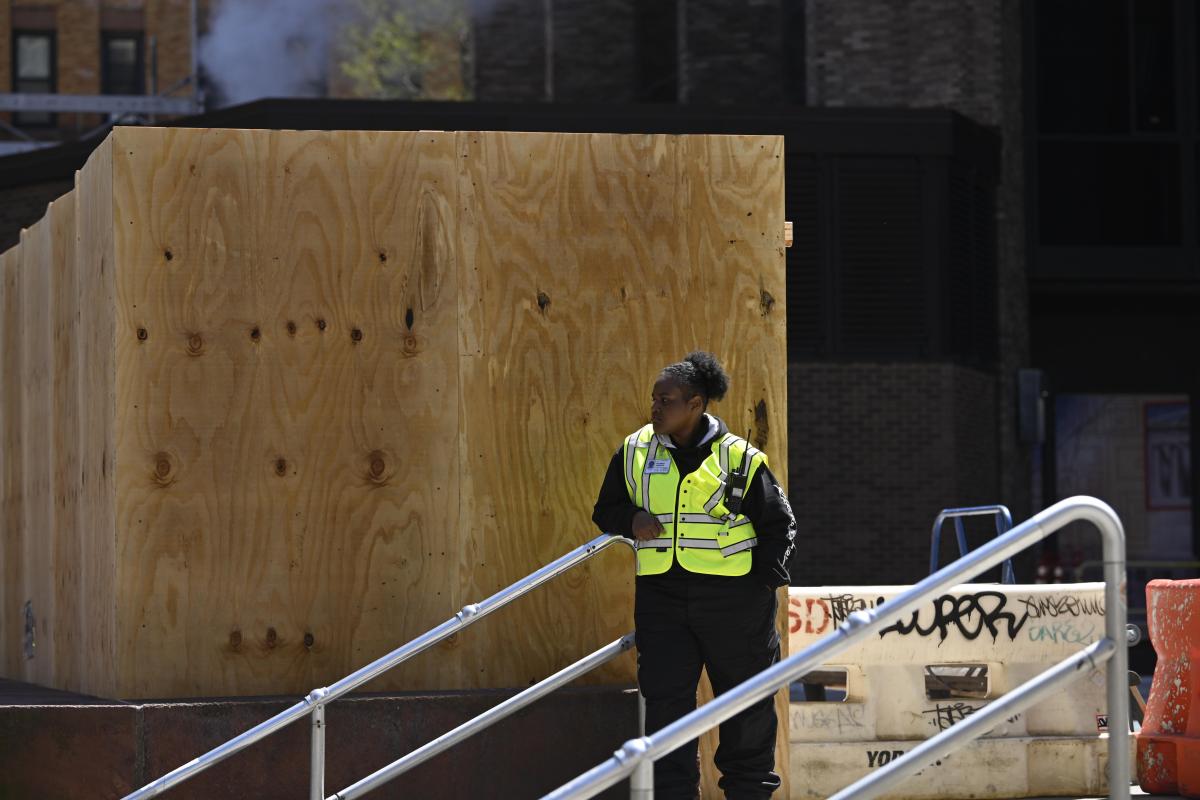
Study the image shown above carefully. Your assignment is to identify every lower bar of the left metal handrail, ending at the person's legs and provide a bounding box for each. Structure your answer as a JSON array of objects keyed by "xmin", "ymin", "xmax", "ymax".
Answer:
[{"xmin": 329, "ymin": 633, "xmax": 634, "ymax": 800}]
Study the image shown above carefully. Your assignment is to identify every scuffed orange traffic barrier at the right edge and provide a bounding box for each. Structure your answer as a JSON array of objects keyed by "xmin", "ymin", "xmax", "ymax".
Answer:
[{"xmin": 1138, "ymin": 581, "xmax": 1200, "ymax": 798}]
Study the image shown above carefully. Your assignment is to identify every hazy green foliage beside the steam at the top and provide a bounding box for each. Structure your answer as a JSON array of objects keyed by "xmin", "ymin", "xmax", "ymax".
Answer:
[{"xmin": 337, "ymin": 0, "xmax": 472, "ymax": 100}]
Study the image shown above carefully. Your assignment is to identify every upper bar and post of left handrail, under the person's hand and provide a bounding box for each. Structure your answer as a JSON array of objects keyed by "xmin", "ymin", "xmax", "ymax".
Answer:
[{"xmin": 125, "ymin": 534, "xmax": 636, "ymax": 800}]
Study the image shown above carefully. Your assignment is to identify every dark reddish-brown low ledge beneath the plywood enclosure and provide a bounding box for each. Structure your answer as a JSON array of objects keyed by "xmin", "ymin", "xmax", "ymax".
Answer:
[{"xmin": 0, "ymin": 681, "xmax": 637, "ymax": 800}]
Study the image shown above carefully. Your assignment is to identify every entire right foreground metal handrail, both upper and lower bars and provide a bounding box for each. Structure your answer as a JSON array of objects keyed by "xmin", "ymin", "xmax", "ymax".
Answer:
[{"xmin": 544, "ymin": 497, "xmax": 1129, "ymax": 800}]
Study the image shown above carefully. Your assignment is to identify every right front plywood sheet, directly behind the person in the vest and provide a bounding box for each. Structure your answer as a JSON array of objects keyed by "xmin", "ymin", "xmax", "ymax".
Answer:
[{"xmin": 460, "ymin": 133, "xmax": 787, "ymax": 796}]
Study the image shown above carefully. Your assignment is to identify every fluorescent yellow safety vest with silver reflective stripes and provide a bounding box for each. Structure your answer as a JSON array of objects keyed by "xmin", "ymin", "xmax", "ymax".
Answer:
[{"xmin": 622, "ymin": 425, "xmax": 767, "ymax": 577}]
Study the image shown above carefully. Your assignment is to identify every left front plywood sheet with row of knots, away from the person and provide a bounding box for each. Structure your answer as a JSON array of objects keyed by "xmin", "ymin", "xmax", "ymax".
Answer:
[{"xmin": 113, "ymin": 130, "xmax": 463, "ymax": 696}]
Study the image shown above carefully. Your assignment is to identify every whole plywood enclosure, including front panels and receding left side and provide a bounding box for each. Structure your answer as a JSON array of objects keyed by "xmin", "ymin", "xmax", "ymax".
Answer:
[{"xmin": 0, "ymin": 128, "xmax": 787, "ymax": 786}]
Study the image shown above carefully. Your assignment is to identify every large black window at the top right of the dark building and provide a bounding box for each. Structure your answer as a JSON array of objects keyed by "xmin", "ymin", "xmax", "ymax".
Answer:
[{"xmin": 1028, "ymin": 0, "xmax": 1195, "ymax": 257}]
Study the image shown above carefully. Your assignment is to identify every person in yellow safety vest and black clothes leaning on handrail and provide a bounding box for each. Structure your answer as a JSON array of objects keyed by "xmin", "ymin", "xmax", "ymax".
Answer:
[{"xmin": 592, "ymin": 353, "xmax": 796, "ymax": 800}]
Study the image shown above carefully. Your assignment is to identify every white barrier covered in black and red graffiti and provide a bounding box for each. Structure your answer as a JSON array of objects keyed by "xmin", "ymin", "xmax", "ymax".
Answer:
[{"xmin": 788, "ymin": 583, "xmax": 1132, "ymax": 800}]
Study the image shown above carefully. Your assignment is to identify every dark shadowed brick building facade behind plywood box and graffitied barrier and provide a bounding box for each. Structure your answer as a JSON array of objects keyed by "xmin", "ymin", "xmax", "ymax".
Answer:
[{"xmin": 475, "ymin": 0, "xmax": 1200, "ymax": 594}]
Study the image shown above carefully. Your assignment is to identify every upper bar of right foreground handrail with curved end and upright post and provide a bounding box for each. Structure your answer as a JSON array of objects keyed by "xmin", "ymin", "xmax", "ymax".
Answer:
[{"xmin": 546, "ymin": 497, "xmax": 1129, "ymax": 800}]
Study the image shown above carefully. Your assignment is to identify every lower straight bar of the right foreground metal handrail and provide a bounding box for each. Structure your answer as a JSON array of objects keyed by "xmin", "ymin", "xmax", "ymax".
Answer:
[{"xmin": 829, "ymin": 637, "xmax": 1113, "ymax": 800}]
